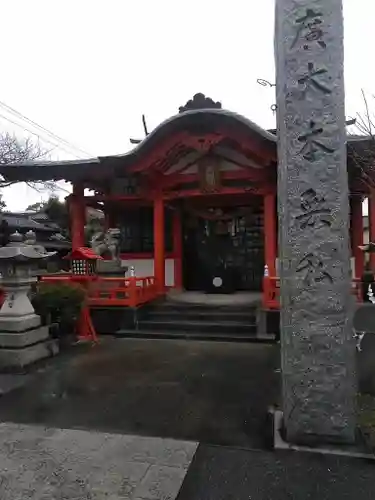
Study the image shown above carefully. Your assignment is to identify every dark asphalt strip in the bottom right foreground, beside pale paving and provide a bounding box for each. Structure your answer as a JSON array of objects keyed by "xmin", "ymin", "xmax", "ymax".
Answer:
[{"xmin": 177, "ymin": 445, "xmax": 375, "ymax": 500}]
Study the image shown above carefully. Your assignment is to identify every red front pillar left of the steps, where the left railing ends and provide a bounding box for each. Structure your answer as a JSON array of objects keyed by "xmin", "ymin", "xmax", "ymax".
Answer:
[{"xmin": 154, "ymin": 196, "xmax": 165, "ymax": 294}]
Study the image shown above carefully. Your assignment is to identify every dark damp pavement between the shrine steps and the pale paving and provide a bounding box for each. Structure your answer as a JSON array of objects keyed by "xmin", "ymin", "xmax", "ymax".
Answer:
[{"xmin": 0, "ymin": 339, "xmax": 279, "ymax": 448}]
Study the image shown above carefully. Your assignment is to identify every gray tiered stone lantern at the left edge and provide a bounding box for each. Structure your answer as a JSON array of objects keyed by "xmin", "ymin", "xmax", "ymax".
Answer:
[{"xmin": 0, "ymin": 232, "xmax": 58, "ymax": 369}]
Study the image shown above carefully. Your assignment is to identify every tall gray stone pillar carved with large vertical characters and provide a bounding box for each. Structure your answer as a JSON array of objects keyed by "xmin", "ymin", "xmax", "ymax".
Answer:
[{"xmin": 275, "ymin": 0, "xmax": 356, "ymax": 443}]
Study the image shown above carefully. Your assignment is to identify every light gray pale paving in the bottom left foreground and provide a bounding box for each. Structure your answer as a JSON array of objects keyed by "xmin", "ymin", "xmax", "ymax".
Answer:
[{"xmin": 0, "ymin": 423, "xmax": 197, "ymax": 500}]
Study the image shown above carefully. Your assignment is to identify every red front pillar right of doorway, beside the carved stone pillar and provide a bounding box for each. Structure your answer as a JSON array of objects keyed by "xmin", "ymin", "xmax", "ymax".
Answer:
[{"xmin": 264, "ymin": 193, "xmax": 277, "ymax": 277}]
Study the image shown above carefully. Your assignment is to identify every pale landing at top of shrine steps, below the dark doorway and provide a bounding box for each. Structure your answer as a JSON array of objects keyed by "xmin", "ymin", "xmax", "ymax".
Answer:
[{"xmin": 167, "ymin": 290, "xmax": 262, "ymax": 307}]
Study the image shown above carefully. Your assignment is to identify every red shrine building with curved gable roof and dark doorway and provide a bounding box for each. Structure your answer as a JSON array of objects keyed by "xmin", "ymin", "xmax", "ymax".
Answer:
[{"xmin": 0, "ymin": 94, "xmax": 375, "ymax": 309}]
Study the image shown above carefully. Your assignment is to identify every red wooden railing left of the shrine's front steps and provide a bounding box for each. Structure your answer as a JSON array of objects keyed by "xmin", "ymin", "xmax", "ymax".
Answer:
[{"xmin": 41, "ymin": 274, "xmax": 158, "ymax": 307}]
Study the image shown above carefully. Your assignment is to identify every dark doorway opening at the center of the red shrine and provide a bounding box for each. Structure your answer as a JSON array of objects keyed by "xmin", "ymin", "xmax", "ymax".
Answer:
[{"xmin": 183, "ymin": 206, "xmax": 264, "ymax": 293}]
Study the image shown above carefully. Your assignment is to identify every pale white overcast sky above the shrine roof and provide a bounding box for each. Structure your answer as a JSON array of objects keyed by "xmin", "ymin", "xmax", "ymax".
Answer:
[{"xmin": 0, "ymin": 0, "xmax": 375, "ymax": 210}]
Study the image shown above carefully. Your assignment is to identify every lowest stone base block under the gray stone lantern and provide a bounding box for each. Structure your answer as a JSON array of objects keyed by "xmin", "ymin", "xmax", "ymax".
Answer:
[{"xmin": 0, "ymin": 340, "xmax": 59, "ymax": 370}]
